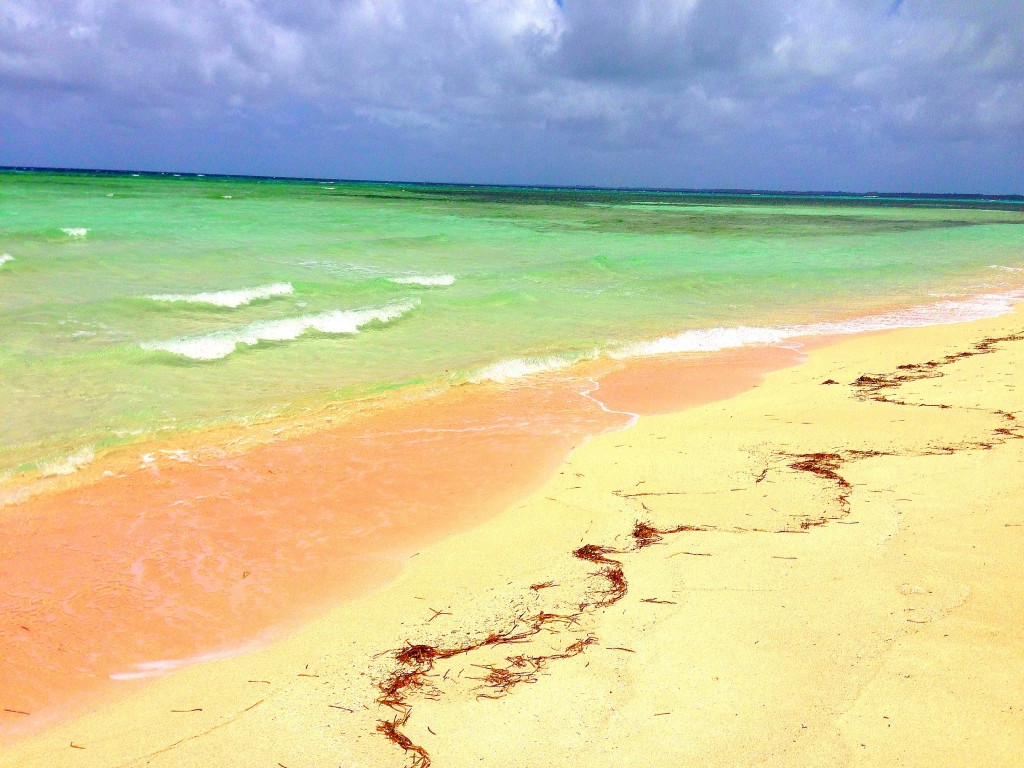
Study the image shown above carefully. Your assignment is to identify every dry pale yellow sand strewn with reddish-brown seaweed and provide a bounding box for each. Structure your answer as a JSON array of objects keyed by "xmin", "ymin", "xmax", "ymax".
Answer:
[{"xmin": 0, "ymin": 312, "xmax": 1024, "ymax": 768}]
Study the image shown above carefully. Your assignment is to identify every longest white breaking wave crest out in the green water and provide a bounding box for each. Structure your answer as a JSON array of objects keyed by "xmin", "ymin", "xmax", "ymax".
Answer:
[{"xmin": 139, "ymin": 299, "xmax": 420, "ymax": 360}]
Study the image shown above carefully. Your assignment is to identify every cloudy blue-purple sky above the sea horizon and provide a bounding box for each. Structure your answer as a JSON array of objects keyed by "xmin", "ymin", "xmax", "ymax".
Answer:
[{"xmin": 0, "ymin": 0, "xmax": 1024, "ymax": 194}]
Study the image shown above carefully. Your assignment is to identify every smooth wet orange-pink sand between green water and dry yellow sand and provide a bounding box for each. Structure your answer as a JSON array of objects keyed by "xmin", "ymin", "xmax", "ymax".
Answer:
[{"xmin": 0, "ymin": 348, "xmax": 799, "ymax": 738}]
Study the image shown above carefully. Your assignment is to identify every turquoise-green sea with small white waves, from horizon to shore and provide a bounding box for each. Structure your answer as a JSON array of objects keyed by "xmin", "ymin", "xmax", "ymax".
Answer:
[{"xmin": 0, "ymin": 172, "xmax": 1024, "ymax": 476}]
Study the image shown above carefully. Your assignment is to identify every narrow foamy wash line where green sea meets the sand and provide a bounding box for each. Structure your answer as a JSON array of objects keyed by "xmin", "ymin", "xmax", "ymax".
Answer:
[{"xmin": 0, "ymin": 280, "xmax": 1024, "ymax": 510}]
